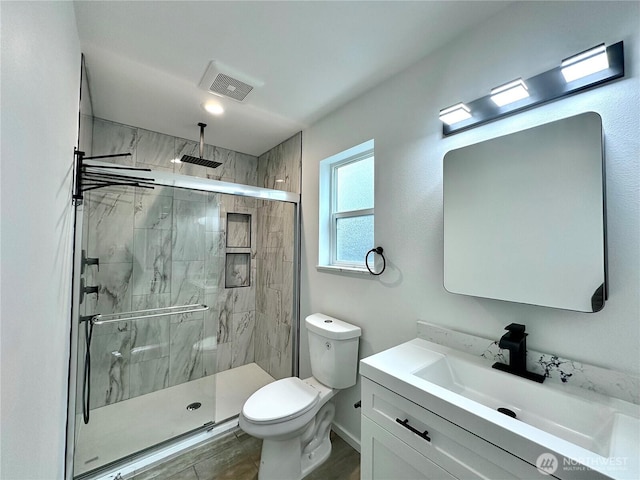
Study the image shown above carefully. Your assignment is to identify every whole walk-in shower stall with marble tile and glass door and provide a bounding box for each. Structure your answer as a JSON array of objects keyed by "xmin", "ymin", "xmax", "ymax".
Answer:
[{"xmin": 67, "ymin": 115, "xmax": 300, "ymax": 478}]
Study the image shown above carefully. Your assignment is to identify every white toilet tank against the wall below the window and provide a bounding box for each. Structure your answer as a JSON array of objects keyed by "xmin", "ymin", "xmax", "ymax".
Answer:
[{"xmin": 305, "ymin": 313, "xmax": 361, "ymax": 388}]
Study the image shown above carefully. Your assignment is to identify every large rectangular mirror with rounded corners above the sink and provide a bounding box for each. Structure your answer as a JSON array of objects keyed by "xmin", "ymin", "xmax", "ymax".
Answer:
[{"xmin": 443, "ymin": 112, "xmax": 607, "ymax": 312}]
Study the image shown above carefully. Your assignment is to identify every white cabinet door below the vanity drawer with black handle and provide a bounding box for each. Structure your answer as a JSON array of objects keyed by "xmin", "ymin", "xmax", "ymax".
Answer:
[{"xmin": 360, "ymin": 416, "xmax": 455, "ymax": 480}]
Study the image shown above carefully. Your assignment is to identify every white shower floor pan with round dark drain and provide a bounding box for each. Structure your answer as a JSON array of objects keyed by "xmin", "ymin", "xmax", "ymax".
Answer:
[{"xmin": 74, "ymin": 363, "xmax": 274, "ymax": 476}]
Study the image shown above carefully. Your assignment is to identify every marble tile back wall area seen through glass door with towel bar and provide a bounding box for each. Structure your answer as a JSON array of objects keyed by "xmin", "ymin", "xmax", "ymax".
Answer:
[{"xmin": 79, "ymin": 188, "xmax": 225, "ymax": 408}]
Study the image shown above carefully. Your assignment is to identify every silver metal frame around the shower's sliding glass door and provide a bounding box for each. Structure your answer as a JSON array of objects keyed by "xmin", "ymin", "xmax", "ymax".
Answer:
[{"xmin": 65, "ymin": 160, "xmax": 301, "ymax": 480}]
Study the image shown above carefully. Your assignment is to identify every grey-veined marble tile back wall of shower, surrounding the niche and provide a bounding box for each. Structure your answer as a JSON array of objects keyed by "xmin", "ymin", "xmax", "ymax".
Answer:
[{"xmin": 78, "ymin": 119, "xmax": 258, "ymax": 408}]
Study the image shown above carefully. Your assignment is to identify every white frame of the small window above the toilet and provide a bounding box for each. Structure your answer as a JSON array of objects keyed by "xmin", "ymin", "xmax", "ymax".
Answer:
[{"xmin": 317, "ymin": 140, "xmax": 375, "ymax": 273}]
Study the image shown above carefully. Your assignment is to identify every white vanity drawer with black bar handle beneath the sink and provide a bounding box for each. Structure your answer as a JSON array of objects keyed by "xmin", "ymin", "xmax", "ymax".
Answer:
[{"xmin": 361, "ymin": 377, "xmax": 554, "ymax": 480}]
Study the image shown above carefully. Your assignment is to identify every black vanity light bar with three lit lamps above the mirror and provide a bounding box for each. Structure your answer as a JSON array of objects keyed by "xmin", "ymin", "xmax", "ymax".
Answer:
[{"xmin": 440, "ymin": 42, "xmax": 624, "ymax": 137}]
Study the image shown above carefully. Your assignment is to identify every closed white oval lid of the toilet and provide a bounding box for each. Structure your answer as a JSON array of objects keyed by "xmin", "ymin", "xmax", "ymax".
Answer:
[{"xmin": 242, "ymin": 377, "xmax": 319, "ymax": 423}]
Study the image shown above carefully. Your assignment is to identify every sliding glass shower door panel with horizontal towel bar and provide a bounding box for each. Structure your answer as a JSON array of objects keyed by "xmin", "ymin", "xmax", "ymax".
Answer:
[{"xmin": 74, "ymin": 187, "xmax": 224, "ymax": 476}]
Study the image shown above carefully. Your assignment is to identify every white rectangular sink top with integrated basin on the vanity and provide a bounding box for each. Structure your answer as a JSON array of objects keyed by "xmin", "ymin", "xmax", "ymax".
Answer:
[{"xmin": 360, "ymin": 339, "xmax": 640, "ymax": 480}]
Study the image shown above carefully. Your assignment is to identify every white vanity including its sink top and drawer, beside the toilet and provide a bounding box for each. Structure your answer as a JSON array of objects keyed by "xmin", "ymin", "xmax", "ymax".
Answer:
[{"xmin": 360, "ymin": 338, "xmax": 640, "ymax": 480}]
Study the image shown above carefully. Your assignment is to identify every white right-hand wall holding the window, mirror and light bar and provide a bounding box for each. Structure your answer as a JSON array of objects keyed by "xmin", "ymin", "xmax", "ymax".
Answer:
[{"xmin": 301, "ymin": 2, "xmax": 640, "ymax": 446}]
